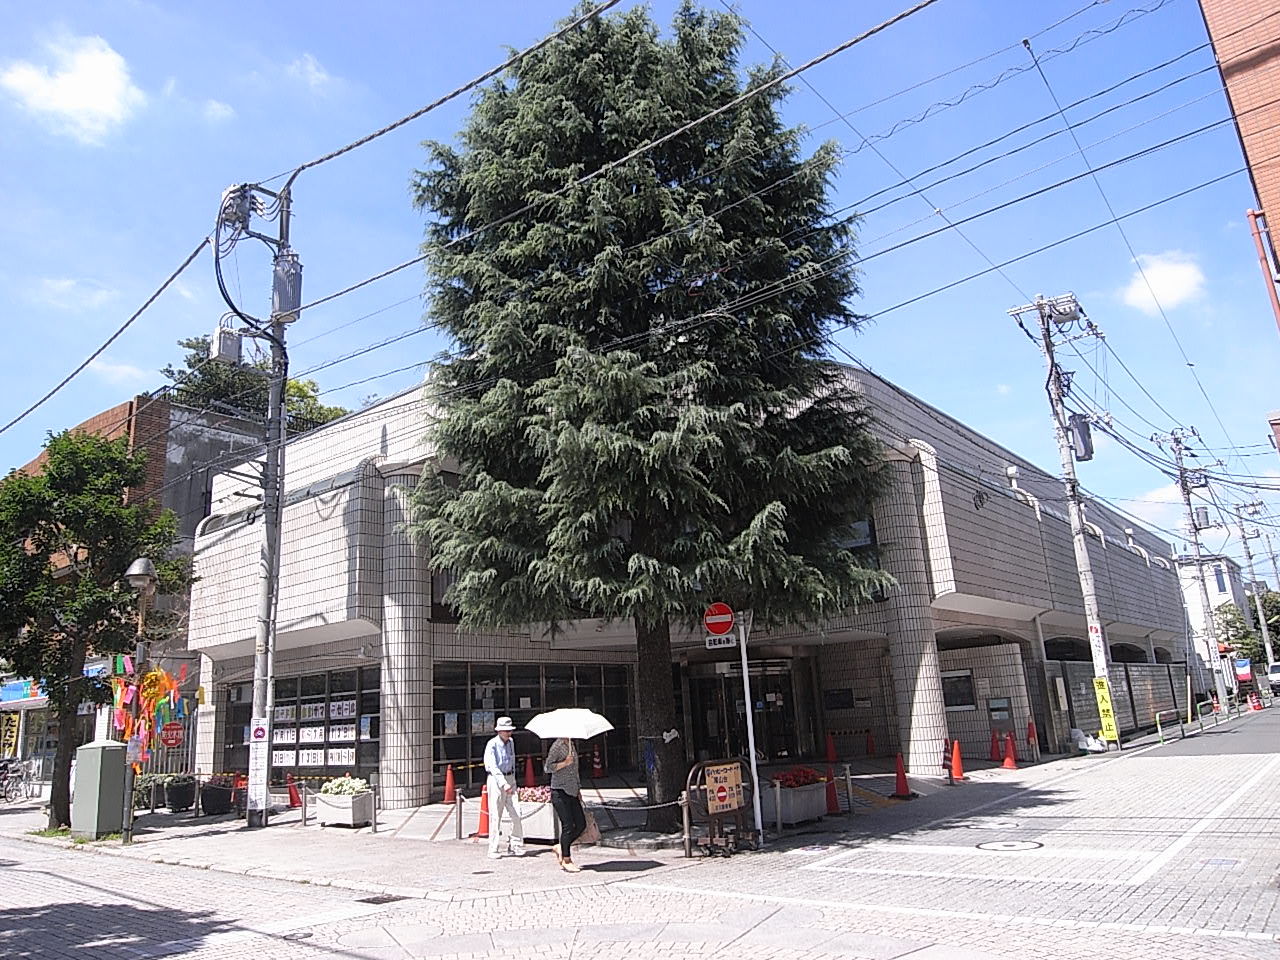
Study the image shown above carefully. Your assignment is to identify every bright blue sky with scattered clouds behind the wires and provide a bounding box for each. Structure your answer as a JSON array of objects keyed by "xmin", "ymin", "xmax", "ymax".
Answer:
[{"xmin": 0, "ymin": 0, "xmax": 1280, "ymax": 573}]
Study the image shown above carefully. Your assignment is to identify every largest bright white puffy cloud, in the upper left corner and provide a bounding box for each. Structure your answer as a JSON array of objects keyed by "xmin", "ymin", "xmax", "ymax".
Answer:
[{"xmin": 0, "ymin": 36, "xmax": 146, "ymax": 143}]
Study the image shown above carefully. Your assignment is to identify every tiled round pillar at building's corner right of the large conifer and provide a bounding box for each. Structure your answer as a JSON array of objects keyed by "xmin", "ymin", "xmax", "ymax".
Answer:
[{"xmin": 876, "ymin": 460, "xmax": 947, "ymax": 777}]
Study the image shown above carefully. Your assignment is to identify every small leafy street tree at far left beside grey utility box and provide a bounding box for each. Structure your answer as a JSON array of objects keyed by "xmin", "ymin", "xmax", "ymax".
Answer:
[{"xmin": 0, "ymin": 431, "xmax": 189, "ymax": 827}]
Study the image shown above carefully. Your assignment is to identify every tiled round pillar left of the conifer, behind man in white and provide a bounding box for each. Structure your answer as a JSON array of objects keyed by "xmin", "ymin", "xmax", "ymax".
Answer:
[{"xmin": 379, "ymin": 474, "xmax": 433, "ymax": 809}]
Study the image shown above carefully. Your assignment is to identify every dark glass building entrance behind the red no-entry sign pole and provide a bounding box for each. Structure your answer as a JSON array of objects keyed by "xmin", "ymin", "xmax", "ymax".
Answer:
[{"xmin": 682, "ymin": 658, "xmax": 818, "ymax": 763}]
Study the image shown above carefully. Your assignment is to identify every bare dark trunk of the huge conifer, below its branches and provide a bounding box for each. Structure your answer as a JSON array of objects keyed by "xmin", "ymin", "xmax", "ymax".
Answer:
[{"xmin": 636, "ymin": 620, "xmax": 685, "ymax": 833}]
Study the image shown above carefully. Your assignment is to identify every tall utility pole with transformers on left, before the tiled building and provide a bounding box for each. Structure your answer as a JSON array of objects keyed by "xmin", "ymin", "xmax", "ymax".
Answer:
[{"xmin": 214, "ymin": 177, "xmax": 302, "ymax": 827}]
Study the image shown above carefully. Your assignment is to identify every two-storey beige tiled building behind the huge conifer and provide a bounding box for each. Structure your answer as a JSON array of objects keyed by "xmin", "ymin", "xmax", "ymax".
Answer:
[{"xmin": 189, "ymin": 370, "xmax": 1185, "ymax": 806}]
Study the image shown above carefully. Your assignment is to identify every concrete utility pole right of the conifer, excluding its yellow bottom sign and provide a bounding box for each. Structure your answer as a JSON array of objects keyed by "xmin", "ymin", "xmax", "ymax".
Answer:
[{"xmin": 1009, "ymin": 293, "xmax": 1110, "ymax": 691}]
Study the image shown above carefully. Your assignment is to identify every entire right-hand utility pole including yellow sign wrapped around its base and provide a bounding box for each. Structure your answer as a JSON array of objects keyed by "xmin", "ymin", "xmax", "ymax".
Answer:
[{"xmin": 1009, "ymin": 293, "xmax": 1120, "ymax": 745}]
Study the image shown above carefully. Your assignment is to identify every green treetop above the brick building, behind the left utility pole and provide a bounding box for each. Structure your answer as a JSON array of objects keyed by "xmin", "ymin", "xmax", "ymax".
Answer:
[{"xmin": 160, "ymin": 337, "xmax": 351, "ymax": 424}]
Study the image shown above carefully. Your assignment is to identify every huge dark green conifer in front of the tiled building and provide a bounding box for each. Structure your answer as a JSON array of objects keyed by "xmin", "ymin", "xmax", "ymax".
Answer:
[{"xmin": 411, "ymin": 4, "xmax": 888, "ymax": 828}]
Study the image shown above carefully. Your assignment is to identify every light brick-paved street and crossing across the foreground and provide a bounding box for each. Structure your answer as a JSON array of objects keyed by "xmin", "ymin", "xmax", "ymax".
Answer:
[{"xmin": 0, "ymin": 710, "xmax": 1280, "ymax": 960}]
